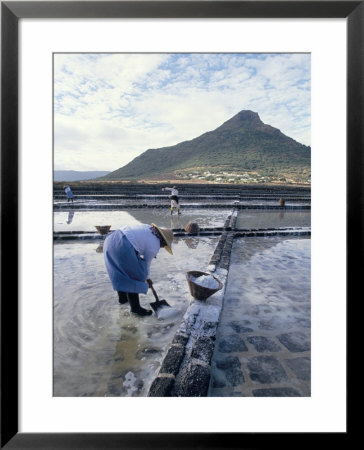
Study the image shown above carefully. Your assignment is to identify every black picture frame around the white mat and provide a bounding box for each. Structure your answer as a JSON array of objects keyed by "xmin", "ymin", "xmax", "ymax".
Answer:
[{"xmin": 1, "ymin": 0, "xmax": 356, "ymax": 449}]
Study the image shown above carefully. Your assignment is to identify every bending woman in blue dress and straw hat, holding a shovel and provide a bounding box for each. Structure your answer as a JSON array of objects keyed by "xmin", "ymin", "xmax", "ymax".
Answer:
[{"xmin": 104, "ymin": 223, "xmax": 173, "ymax": 316}]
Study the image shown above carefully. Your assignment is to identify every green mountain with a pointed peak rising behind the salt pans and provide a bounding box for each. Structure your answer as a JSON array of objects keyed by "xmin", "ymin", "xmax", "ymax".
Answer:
[{"xmin": 104, "ymin": 111, "xmax": 311, "ymax": 182}]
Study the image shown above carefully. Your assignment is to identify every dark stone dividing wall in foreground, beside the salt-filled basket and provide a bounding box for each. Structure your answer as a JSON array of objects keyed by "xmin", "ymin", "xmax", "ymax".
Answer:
[{"xmin": 148, "ymin": 232, "xmax": 233, "ymax": 397}]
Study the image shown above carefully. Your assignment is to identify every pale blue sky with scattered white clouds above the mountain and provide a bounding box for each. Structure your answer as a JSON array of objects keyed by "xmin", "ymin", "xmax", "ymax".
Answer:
[{"xmin": 54, "ymin": 53, "xmax": 311, "ymax": 171}]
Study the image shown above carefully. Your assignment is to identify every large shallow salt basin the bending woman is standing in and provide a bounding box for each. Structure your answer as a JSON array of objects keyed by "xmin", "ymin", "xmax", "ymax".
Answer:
[{"xmin": 53, "ymin": 237, "xmax": 218, "ymax": 397}]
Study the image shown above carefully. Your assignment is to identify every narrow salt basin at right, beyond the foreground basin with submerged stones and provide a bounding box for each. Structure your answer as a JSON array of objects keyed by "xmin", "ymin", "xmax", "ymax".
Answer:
[{"xmin": 236, "ymin": 209, "xmax": 311, "ymax": 229}]
